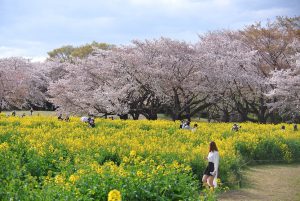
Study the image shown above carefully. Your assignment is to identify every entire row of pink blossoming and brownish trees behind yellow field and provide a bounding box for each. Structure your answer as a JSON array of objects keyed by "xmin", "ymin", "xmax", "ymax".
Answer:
[{"xmin": 0, "ymin": 17, "xmax": 300, "ymax": 123}]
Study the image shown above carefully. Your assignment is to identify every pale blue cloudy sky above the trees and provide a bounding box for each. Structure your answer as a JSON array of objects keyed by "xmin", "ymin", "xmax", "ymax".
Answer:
[{"xmin": 0, "ymin": 0, "xmax": 300, "ymax": 61}]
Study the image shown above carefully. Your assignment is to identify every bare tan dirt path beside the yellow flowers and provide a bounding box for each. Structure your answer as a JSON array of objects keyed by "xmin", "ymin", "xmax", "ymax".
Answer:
[{"xmin": 218, "ymin": 164, "xmax": 300, "ymax": 201}]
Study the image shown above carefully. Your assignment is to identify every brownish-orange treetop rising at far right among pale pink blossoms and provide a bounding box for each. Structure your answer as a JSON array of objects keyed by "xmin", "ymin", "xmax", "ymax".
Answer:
[{"xmin": 240, "ymin": 17, "xmax": 300, "ymax": 73}]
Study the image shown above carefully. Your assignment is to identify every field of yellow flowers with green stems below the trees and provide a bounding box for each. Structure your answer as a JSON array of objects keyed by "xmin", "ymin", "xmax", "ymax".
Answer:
[{"xmin": 0, "ymin": 116, "xmax": 300, "ymax": 200}]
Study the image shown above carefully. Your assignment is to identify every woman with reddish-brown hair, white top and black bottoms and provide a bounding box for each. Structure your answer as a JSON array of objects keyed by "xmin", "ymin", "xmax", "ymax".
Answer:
[{"xmin": 202, "ymin": 141, "xmax": 220, "ymax": 188}]
